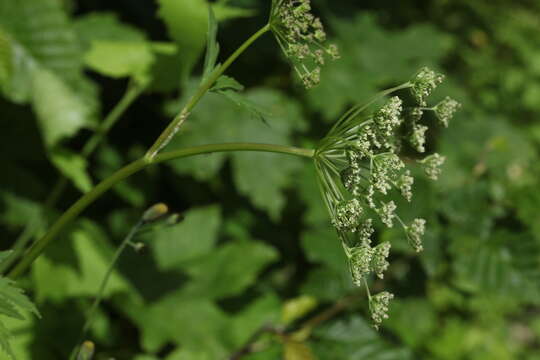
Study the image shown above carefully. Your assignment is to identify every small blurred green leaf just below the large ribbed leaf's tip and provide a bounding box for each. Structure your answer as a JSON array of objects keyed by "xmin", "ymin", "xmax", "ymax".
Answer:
[{"xmin": 50, "ymin": 147, "xmax": 92, "ymax": 193}]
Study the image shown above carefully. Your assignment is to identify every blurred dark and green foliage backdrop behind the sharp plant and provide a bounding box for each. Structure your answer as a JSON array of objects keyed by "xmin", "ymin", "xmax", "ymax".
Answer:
[{"xmin": 0, "ymin": 0, "xmax": 540, "ymax": 360}]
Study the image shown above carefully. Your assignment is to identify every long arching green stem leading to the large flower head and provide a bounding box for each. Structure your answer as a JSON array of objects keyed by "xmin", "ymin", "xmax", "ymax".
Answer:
[{"xmin": 8, "ymin": 143, "xmax": 315, "ymax": 278}]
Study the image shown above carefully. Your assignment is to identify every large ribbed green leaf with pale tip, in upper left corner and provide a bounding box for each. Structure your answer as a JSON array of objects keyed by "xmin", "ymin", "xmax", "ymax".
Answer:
[{"xmin": 0, "ymin": 0, "xmax": 96, "ymax": 146}]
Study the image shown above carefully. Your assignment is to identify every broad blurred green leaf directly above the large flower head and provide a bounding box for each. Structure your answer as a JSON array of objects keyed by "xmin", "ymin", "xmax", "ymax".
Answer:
[{"xmin": 307, "ymin": 13, "xmax": 451, "ymax": 121}]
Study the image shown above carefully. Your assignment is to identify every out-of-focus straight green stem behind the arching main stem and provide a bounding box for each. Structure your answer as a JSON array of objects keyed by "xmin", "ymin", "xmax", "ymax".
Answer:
[{"xmin": 0, "ymin": 81, "xmax": 144, "ymax": 274}]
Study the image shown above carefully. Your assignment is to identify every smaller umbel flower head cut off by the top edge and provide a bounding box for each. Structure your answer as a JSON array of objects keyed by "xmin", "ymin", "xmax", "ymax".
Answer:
[{"xmin": 269, "ymin": 0, "xmax": 339, "ymax": 89}]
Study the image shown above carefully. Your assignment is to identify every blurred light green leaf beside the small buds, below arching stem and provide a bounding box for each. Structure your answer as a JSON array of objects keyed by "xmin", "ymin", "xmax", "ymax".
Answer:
[{"xmin": 149, "ymin": 206, "xmax": 221, "ymax": 270}]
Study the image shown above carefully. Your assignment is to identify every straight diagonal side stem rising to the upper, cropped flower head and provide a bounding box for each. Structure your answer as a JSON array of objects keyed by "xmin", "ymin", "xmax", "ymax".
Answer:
[{"xmin": 145, "ymin": 24, "xmax": 270, "ymax": 160}]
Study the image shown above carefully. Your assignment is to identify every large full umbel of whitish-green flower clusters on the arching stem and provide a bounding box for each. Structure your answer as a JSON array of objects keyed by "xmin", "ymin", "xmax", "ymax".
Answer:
[{"xmin": 314, "ymin": 68, "xmax": 459, "ymax": 326}]
